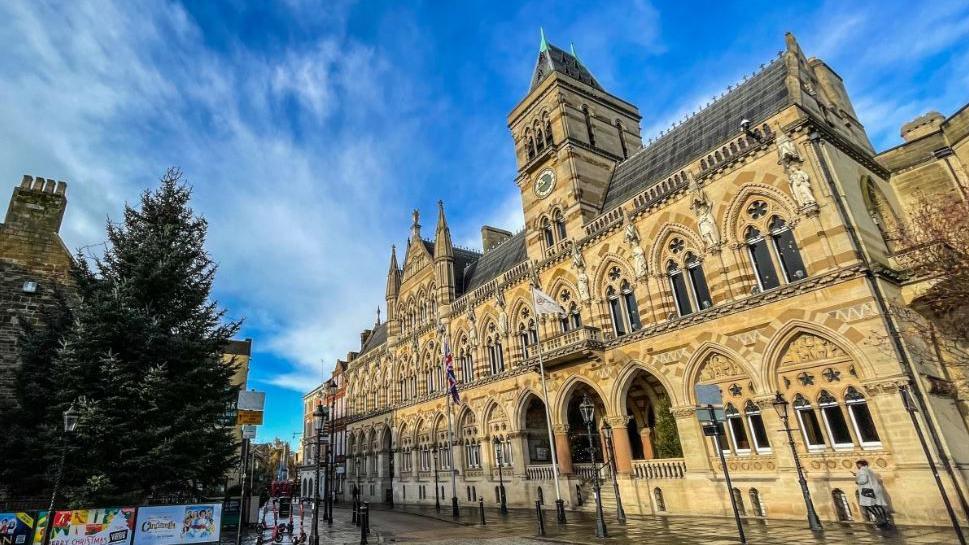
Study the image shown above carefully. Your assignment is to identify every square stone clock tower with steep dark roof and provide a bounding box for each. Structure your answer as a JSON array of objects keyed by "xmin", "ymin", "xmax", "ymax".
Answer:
[{"xmin": 508, "ymin": 32, "xmax": 642, "ymax": 260}]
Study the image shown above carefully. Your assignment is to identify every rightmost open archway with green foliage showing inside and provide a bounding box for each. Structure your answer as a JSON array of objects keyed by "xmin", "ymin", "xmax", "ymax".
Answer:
[{"xmin": 625, "ymin": 369, "xmax": 683, "ymax": 460}]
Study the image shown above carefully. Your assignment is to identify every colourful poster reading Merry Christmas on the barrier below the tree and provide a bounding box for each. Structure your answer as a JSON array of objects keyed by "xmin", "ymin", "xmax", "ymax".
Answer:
[{"xmin": 50, "ymin": 507, "xmax": 135, "ymax": 545}]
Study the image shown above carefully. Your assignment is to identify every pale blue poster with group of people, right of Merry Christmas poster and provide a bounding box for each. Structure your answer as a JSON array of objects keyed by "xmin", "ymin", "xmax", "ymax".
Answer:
[{"xmin": 134, "ymin": 503, "xmax": 222, "ymax": 545}]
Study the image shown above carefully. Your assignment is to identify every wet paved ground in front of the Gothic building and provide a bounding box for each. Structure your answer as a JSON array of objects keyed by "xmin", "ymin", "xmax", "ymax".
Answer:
[{"xmin": 222, "ymin": 505, "xmax": 957, "ymax": 545}]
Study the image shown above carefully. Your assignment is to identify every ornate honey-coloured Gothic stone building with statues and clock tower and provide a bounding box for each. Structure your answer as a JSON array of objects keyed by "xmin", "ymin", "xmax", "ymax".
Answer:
[{"xmin": 334, "ymin": 35, "xmax": 969, "ymax": 523}]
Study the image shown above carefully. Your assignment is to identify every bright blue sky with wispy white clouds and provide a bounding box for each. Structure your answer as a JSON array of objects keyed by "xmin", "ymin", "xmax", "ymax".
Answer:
[{"xmin": 0, "ymin": 0, "xmax": 969, "ymax": 440}]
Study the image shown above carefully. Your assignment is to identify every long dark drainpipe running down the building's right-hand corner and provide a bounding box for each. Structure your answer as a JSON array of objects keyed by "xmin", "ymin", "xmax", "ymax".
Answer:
[{"xmin": 808, "ymin": 126, "xmax": 969, "ymax": 520}]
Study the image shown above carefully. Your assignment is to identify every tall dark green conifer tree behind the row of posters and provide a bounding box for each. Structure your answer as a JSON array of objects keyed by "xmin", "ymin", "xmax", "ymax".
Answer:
[{"xmin": 51, "ymin": 169, "xmax": 239, "ymax": 505}]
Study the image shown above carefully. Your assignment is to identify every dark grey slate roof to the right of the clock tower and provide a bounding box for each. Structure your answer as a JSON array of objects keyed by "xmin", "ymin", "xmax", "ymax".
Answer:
[{"xmin": 602, "ymin": 58, "xmax": 790, "ymax": 213}]
